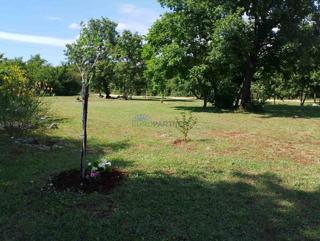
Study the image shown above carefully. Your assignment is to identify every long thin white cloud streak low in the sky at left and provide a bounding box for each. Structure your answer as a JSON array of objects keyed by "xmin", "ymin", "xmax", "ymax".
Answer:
[{"xmin": 0, "ymin": 31, "xmax": 75, "ymax": 47}]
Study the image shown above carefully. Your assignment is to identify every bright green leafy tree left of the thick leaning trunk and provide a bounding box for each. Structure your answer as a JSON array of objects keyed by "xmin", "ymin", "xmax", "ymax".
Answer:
[{"xmin": 145, "ymin": 1, "xmax": 244, "ymax": 107}]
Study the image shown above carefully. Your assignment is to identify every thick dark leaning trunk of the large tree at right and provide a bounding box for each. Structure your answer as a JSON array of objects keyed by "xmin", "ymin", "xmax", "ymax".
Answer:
[{"xmin": 240, "ymin": 55, "xmax": 257, "ymax": 109}]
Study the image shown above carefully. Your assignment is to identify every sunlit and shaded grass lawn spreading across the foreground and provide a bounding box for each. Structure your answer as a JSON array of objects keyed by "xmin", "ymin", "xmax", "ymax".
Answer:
[{"xmin": 0, "ymin": 97, "xmax": 320, "ymax": 241}]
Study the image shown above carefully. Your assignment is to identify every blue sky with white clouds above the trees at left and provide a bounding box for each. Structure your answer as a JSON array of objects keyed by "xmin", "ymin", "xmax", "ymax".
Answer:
[{"xmin": 0, "ymin": 0, "xmax": 166, "ymax": 65}]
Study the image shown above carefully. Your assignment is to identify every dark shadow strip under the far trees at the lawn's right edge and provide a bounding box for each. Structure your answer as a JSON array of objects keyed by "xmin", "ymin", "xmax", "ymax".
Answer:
[{"xmin": 173, "ymin": 104, "xmax": 320, "ymax": 118}]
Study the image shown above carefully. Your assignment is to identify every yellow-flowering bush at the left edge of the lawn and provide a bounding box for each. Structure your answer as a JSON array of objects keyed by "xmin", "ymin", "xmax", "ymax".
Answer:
[{"xmin": 0, "ymin": 66, "xmax": 48, "ymax": 134}]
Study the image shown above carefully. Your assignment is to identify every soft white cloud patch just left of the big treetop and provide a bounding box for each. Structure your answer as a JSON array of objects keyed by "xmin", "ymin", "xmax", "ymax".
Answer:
[{"xmin": 117, "ymin": 4, "xmax": 160, "ymax": 34}]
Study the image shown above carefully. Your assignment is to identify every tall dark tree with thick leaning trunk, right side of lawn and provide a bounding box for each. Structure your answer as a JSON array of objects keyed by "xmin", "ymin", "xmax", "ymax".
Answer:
[{"xmin": 216, "ymin": 0, "xmax": 317, "ymax": 109}]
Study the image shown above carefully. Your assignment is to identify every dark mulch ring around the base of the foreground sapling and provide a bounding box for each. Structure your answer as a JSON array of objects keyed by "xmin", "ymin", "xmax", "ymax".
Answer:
[{"xmin": 51, "ymin": 168, "xmax": 128, "ymax": 194}]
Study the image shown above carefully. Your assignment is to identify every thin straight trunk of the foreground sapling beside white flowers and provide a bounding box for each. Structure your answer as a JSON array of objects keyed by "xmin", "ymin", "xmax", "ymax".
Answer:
[{"xmin": 80, "ymin": 84, "xmax": 89, "ymax": 179}]
